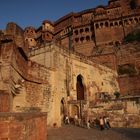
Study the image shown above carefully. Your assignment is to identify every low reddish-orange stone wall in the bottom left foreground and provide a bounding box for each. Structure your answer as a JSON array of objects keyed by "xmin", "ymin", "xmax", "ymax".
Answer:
[{"xmin": 0, "ymin": 113, "xmax": 47, "ymax": 140}]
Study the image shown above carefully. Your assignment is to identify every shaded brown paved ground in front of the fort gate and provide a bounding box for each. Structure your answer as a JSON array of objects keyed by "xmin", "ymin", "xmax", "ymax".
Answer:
[{"xmin": 47, "ymin": 125, "xmax": 140, "ymax": 140}]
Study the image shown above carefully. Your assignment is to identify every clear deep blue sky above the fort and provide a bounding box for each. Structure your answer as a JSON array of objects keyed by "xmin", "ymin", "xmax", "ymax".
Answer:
[{"xmin": 0, "ymin": 0, "xmax": 108, "ymax": 29}]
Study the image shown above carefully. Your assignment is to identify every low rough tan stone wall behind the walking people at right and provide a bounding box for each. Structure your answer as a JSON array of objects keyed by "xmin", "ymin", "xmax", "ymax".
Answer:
[{"xmin": 88, "ymin": 98, "xmax": 140, "ymax": 128}]
